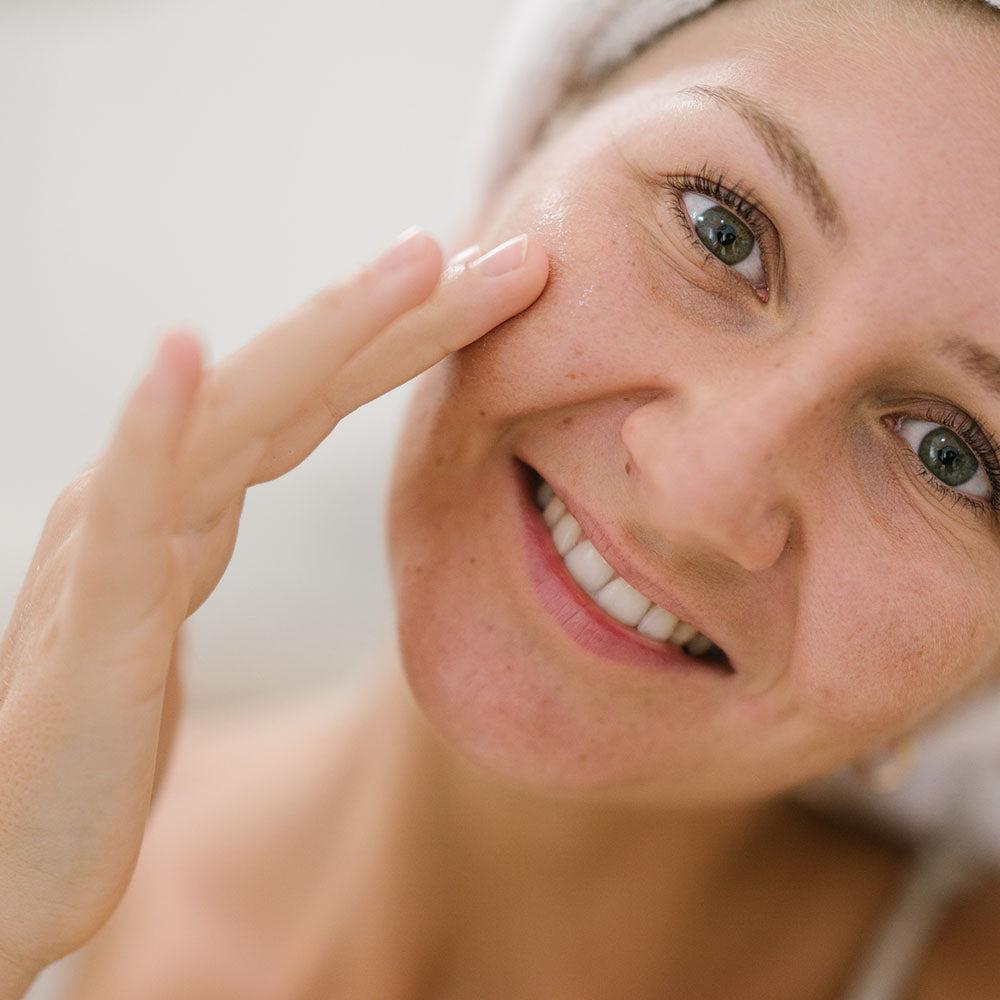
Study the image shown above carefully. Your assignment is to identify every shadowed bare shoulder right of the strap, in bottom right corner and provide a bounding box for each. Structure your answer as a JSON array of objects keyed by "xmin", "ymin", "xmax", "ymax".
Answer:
[{"xmin": 912, "ymin": 869, "xmax": 1000, "ymax": 1000}]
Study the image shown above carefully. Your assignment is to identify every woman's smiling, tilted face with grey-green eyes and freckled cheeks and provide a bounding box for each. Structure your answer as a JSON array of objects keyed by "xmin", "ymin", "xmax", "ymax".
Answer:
[{"xmin": 389, "ymin": 0, "xmax": 1000, "ymax": 804}]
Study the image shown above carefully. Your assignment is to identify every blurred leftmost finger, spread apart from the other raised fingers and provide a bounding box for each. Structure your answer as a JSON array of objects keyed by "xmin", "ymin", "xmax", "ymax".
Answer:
[{"xmin": 69, "ymin": 330, "xmax": 202, "ymax": 645}]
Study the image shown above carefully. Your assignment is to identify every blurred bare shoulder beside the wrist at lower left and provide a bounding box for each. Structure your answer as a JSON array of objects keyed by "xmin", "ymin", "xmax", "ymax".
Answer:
[{"xmin": 65, "ymin": 692, "xmax": 364, "ymax": 1000}]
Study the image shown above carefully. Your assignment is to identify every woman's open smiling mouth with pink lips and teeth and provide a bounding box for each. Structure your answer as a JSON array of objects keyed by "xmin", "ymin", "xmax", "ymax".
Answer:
[{"xmin": 518, "ymin": 460, "xmax": 734, "ymax": 676}]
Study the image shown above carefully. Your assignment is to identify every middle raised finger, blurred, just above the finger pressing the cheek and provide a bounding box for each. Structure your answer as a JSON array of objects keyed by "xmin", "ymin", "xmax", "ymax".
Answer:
[{"xmin": 204, "ymin": 229, "xmax": 441, "ymax": 439}]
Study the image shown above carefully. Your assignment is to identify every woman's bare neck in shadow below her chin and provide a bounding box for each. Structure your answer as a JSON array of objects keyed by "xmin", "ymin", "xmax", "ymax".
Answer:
[{"xmin": 312, "ymin": 644, "xmax": 812, "ymax": 997}]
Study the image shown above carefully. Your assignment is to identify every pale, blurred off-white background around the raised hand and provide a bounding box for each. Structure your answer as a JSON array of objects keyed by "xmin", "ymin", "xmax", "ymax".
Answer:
[{"xmin": 0, "ymin": 0, "xmax": 508, "ymax": 724}]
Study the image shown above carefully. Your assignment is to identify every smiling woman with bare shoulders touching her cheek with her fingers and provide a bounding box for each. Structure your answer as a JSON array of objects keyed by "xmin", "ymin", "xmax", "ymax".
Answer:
[{"xmin": 0, "ymin": 0, "xmax": 1000, "ymax": 1000}]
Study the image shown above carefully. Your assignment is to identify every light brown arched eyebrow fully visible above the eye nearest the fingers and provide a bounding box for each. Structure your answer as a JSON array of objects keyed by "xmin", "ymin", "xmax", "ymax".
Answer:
[{"xmin": 681, "ymin": 84, "xmax": 844, "ymax": 238}]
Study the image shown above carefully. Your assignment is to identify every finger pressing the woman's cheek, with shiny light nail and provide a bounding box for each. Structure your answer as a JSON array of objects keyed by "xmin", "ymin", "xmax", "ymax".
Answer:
[{"xmin": 253, "ymin": 236, "xmax": 549, "ymax": 482}]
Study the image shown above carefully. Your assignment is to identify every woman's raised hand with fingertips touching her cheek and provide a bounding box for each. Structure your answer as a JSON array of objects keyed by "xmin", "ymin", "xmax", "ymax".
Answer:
[{"xmin": 0, "ymin": 225, "xmax": 548, "ymax": 984}]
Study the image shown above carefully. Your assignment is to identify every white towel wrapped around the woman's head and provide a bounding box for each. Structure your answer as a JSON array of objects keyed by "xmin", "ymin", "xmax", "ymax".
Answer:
[{"xmin": 462, "ymin": 0, "xmax": 1000, "ymax": 861}]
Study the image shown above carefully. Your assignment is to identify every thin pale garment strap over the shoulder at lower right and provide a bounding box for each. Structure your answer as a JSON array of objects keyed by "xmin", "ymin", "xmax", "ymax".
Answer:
[{"xmin": 844, "ymin": 841, "xmax": 986, "ymax": 1000}]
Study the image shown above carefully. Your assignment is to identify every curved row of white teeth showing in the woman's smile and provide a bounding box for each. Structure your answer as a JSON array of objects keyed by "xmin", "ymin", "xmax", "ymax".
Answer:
[{"xmin": 535, "ymin": 472, "xmax": 715, "ymax": 656}]
